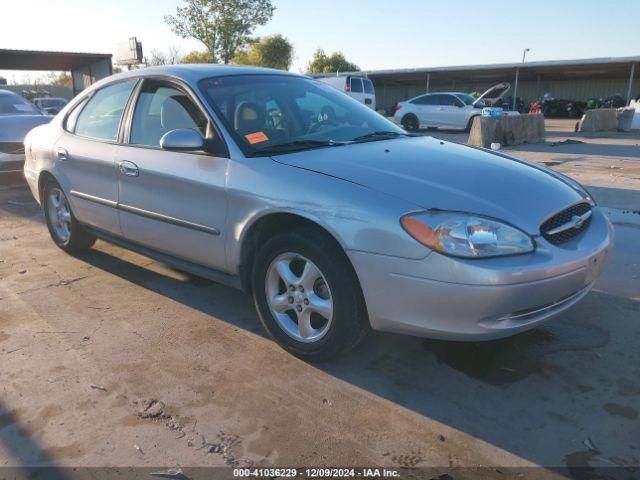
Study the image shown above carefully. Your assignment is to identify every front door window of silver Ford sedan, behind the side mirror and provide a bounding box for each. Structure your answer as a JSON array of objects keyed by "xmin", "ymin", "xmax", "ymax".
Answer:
[{"xmin": 129, "ymin": 81, "xmax": 209, "ymax": 147}]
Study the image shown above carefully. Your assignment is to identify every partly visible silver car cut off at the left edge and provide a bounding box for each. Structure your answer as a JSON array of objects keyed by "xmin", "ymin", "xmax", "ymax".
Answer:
[{"xmin": 0, "ymin": 90, "xmax": 51, "ymax": 181}]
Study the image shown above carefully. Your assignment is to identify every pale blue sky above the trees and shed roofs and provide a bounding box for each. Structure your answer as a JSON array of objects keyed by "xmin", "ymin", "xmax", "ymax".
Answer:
[{"xmin": 0, "ymin": 0, "xmax": 640, "ymax": 81}]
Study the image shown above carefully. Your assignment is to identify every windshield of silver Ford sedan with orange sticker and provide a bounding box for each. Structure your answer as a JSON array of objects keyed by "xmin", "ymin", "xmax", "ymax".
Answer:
[{"xmin": 199, "ymin": 75, "xmax": 405, "ymax": 155}]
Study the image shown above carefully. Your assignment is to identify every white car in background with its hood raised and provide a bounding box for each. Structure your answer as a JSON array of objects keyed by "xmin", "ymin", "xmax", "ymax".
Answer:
[{"xmin": 393, "ymin": 82, "xmax": 517, "ymax": 131}]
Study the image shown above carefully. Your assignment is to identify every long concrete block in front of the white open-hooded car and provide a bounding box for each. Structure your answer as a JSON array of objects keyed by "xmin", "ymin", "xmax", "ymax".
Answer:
[{"xmin": 467, "ymin": 114, "xmax": 545, "ymax": 148}]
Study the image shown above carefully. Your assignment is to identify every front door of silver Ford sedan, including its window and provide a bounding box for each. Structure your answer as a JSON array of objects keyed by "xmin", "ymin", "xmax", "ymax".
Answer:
[{"xmin": 116, "ymin": 79, "xmax": 228, "ymax": 270}]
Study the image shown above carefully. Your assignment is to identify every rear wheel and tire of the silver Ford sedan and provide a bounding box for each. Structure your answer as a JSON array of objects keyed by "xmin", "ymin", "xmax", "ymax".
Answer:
[{"xmin": 42, "ymin": 180, "xmax": 96, "ymax": 253}]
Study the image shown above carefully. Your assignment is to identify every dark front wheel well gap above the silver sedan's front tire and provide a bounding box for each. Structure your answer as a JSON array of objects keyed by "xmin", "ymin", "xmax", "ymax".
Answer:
[{"xmin": 239, "ymin": 213, "xmax": 344, "ymax": 292}]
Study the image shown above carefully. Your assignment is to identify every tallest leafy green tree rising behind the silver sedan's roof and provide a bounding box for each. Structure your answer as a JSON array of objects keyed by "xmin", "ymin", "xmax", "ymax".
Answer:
[{"xmin": 165, "ymin": 0, "xmax": 275, "ymax": 63}]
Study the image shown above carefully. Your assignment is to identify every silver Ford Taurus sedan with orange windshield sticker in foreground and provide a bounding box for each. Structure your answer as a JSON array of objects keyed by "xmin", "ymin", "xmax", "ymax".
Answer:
[{"xmin": 25, "ymin": 65, "xmax": 613, "ymax": 358}]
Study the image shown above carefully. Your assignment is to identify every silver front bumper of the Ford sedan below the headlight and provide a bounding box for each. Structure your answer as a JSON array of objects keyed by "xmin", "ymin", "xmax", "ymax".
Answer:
[{"xmin": 347, "ymin": 208, "xmax": 613, "ymax": 340}]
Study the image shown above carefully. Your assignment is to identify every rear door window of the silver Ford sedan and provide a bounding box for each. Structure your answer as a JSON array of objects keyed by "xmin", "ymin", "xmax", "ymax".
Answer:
[{"xmin": 74, "ymin": 80, "xmax": 136, "ymax": 141}]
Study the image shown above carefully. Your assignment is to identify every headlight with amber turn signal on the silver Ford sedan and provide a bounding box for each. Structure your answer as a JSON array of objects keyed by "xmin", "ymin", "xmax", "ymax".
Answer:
[{"xmin": 400, "ymin": 211, "xmax": 535, "ymax": 258}]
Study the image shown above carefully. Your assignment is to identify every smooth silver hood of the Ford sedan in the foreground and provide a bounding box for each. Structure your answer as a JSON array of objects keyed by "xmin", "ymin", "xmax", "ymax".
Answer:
[{"xmin": 273, "ymin": 137, "xmax": 587, "ymax": 235}]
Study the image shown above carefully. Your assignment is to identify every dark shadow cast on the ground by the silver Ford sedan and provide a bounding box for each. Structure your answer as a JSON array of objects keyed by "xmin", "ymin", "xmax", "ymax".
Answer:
[{"xmin": 71, "ymin": 244, "xmax": 640, "ymax": 468}]
